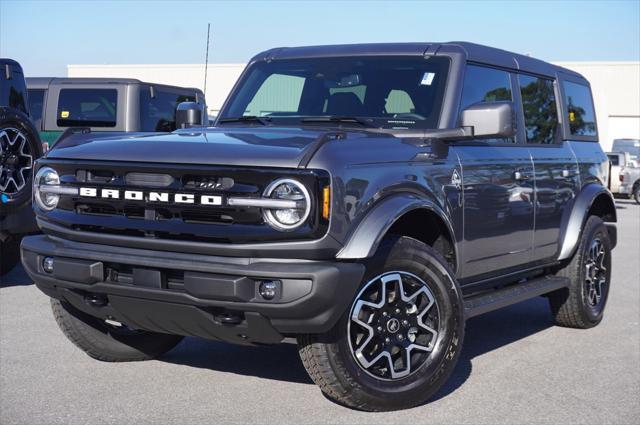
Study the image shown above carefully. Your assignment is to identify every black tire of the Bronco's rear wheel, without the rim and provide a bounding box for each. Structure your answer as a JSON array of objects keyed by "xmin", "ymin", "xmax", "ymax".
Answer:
[{"xmin": 548, "ymin": 216, "xmax": 611, "ymax": 329}]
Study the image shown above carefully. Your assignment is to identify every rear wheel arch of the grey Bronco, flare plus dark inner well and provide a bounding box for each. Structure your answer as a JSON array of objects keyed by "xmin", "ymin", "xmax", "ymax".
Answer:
[{"xmin": 558, "ymin": 184, "xmax": 617, "ymax": 260}]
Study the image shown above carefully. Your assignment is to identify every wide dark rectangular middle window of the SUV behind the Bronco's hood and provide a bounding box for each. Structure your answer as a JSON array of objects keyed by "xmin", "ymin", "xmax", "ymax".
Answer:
[{"xmin": 57, "ymin": 89, "xmax": 118, "ymax": 127}]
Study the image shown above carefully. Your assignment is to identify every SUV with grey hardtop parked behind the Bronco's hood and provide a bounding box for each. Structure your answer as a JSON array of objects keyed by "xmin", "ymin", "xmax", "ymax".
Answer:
[{"xmin": 27, "ymin": 78, "xmax": 207, "ymax": 146}]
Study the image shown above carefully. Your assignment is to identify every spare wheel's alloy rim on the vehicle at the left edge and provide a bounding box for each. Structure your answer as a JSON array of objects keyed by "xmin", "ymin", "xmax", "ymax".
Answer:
[{"xmin": 0, "ymin": 128, "xmax": 33, "ymax": 195}]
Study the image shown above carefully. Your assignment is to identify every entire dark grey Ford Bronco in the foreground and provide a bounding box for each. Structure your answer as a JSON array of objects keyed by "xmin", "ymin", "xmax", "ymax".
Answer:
[{"xmin": 22, "ymin": 42, "xmax": 616, "ymax": 410}]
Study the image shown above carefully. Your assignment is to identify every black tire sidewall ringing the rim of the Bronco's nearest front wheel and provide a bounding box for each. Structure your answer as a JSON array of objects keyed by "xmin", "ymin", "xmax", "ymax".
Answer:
[{"xmin": 333, "ymin": 237, "xmax": 464, "ymax": 406}]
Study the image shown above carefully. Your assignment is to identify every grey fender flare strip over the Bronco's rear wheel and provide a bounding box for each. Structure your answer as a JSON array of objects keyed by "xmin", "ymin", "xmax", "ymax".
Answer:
[{"xmin": 558, "ymin": 183, "xmax": 616, "ymax": 260}]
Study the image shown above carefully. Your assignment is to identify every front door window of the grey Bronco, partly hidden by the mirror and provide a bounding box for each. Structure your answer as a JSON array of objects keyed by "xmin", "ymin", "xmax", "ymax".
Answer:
[{"xmin": 460, "ymin": 65, "xmax": 515, "ymax": 143}]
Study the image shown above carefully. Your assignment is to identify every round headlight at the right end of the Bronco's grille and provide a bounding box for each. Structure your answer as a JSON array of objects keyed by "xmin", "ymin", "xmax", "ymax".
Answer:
[{"xmin": 263, "ymin": 179, "xmax": 311, "ymax": 230}]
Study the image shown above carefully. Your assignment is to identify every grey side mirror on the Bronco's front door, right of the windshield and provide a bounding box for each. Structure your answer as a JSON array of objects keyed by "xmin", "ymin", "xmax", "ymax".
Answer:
[{"xmin": 462, "ymin": 102, "xmax": 515, "ymax": 138}]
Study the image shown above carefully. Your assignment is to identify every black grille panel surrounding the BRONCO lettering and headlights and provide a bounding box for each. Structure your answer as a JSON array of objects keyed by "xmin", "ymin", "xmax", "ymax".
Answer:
[{"xmin": 40, "ymin": 159, "xmax": 329, "ymax": 243}]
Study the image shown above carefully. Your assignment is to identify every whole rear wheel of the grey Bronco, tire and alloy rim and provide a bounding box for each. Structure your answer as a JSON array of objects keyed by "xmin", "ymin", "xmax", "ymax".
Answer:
[{"xmin": 549, "ymin": 216, "xmax": 611, "ymax": 329}]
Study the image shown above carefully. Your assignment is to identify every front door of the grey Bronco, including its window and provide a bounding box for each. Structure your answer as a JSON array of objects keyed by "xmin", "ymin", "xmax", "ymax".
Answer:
[{"xmin": 453, "ymin": 65, "xmax": 534, "ymax": 280}]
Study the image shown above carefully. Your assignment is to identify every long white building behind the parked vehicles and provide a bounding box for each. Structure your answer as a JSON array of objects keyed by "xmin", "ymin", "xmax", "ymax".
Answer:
[{"xmin": 67, "ymin": 62, "xmax": 640, "ymax": 150}]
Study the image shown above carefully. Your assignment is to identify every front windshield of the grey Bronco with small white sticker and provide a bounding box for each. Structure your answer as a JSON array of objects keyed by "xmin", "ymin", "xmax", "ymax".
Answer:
[{"xmin": 218, "ymin": 57, "xmax": 449, "ymax": 128}]
